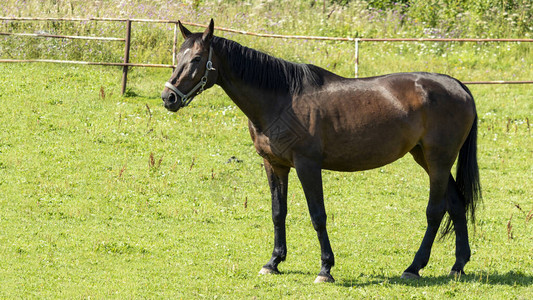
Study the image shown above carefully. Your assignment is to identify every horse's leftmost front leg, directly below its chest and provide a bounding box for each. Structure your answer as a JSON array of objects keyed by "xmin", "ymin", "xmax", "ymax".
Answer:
[{"xmin": 259, "ymin": 159, "xmax": 290, "ymax": 274}]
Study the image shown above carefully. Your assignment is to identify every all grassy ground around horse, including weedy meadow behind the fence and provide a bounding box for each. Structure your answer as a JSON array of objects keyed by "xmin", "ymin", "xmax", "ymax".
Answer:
[{"xmin": 0, "ymin": 0, "xmax": 533, "ymax": 299}]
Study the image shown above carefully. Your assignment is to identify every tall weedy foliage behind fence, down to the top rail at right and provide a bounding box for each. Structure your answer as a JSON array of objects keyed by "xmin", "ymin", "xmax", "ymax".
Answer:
[{"xmin": 0, "ymin": 0, "xmax": 533, "ymax": 64}]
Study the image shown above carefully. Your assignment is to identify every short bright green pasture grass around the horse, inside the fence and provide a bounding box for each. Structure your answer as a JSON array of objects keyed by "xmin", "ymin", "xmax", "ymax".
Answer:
[{"xmin": 0, "ymin": 59, "xmax": 533, "ymax": 299}]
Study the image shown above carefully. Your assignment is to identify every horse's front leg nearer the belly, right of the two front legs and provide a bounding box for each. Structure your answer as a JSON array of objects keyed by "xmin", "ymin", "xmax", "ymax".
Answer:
[{"xmin": 295, "ymin": 159, "xmax": 335, "ymax": 283}]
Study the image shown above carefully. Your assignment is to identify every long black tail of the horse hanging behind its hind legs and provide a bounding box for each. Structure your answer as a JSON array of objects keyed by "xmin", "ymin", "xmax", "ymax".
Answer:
[{"xmin": 441, "ymin": 83, "xmax": 482, "ymax": 237}]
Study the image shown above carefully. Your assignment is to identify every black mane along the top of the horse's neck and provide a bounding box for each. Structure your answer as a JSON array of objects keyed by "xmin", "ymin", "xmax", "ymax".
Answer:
[{"xmin": 211, "ymin": 37, "xmax": 324, "ymax": 94}]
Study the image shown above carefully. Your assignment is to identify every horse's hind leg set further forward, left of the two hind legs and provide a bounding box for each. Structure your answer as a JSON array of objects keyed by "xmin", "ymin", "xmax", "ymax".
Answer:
[{"xmin": 402, "ymin": 146, "xmax": 451, "ymax": 278}]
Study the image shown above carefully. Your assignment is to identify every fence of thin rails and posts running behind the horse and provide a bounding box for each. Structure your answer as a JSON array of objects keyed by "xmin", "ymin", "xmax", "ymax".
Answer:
[{"xmin": 0, "ymin": 17, "xmax": 533, "ymax": 94}]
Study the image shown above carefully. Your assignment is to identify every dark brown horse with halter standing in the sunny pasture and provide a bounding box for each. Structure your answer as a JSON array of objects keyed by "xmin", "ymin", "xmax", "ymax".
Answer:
[{"xmin": 161, "ymin": 20, "xmax": 481, "ymax": 282}]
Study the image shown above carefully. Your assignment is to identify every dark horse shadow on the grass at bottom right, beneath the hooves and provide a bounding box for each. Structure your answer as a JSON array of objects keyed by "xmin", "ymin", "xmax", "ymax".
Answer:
[{"xmin": 336, "ymin": 271, "xmax": 533, "ymax": 287}]
